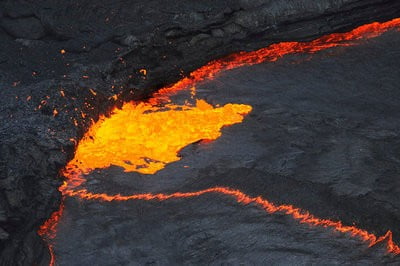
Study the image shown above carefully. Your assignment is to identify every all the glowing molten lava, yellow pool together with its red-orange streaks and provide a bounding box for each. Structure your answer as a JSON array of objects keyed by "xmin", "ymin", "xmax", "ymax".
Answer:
[{"xmin": 39, "ymin": 18, "xmax": 400, "ymax": 265}]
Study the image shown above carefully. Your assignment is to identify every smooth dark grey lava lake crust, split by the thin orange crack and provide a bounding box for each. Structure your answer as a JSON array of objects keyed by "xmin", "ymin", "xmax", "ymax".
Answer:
[{"xmin": 55, "ymin": 32, "xmax": 400, "ymax": 265}]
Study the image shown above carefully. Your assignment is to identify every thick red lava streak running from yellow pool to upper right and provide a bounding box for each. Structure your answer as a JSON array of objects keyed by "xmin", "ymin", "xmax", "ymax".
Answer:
[{"xmin": 150, "ymin": 18, "xmax": 400, "ymax": 103}]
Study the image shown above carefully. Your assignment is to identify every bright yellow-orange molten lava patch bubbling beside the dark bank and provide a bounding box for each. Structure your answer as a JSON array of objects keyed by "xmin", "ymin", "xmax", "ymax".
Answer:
[{"xmin": 67, "ymin": 100, "xmax": 252, "ymax": 174}]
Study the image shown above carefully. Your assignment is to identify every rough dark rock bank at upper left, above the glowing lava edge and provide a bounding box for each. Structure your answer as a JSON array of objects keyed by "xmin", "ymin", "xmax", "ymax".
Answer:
[{"xmin": 0, "ymin": 0, "xmax": 400, "ymax": 265}]
